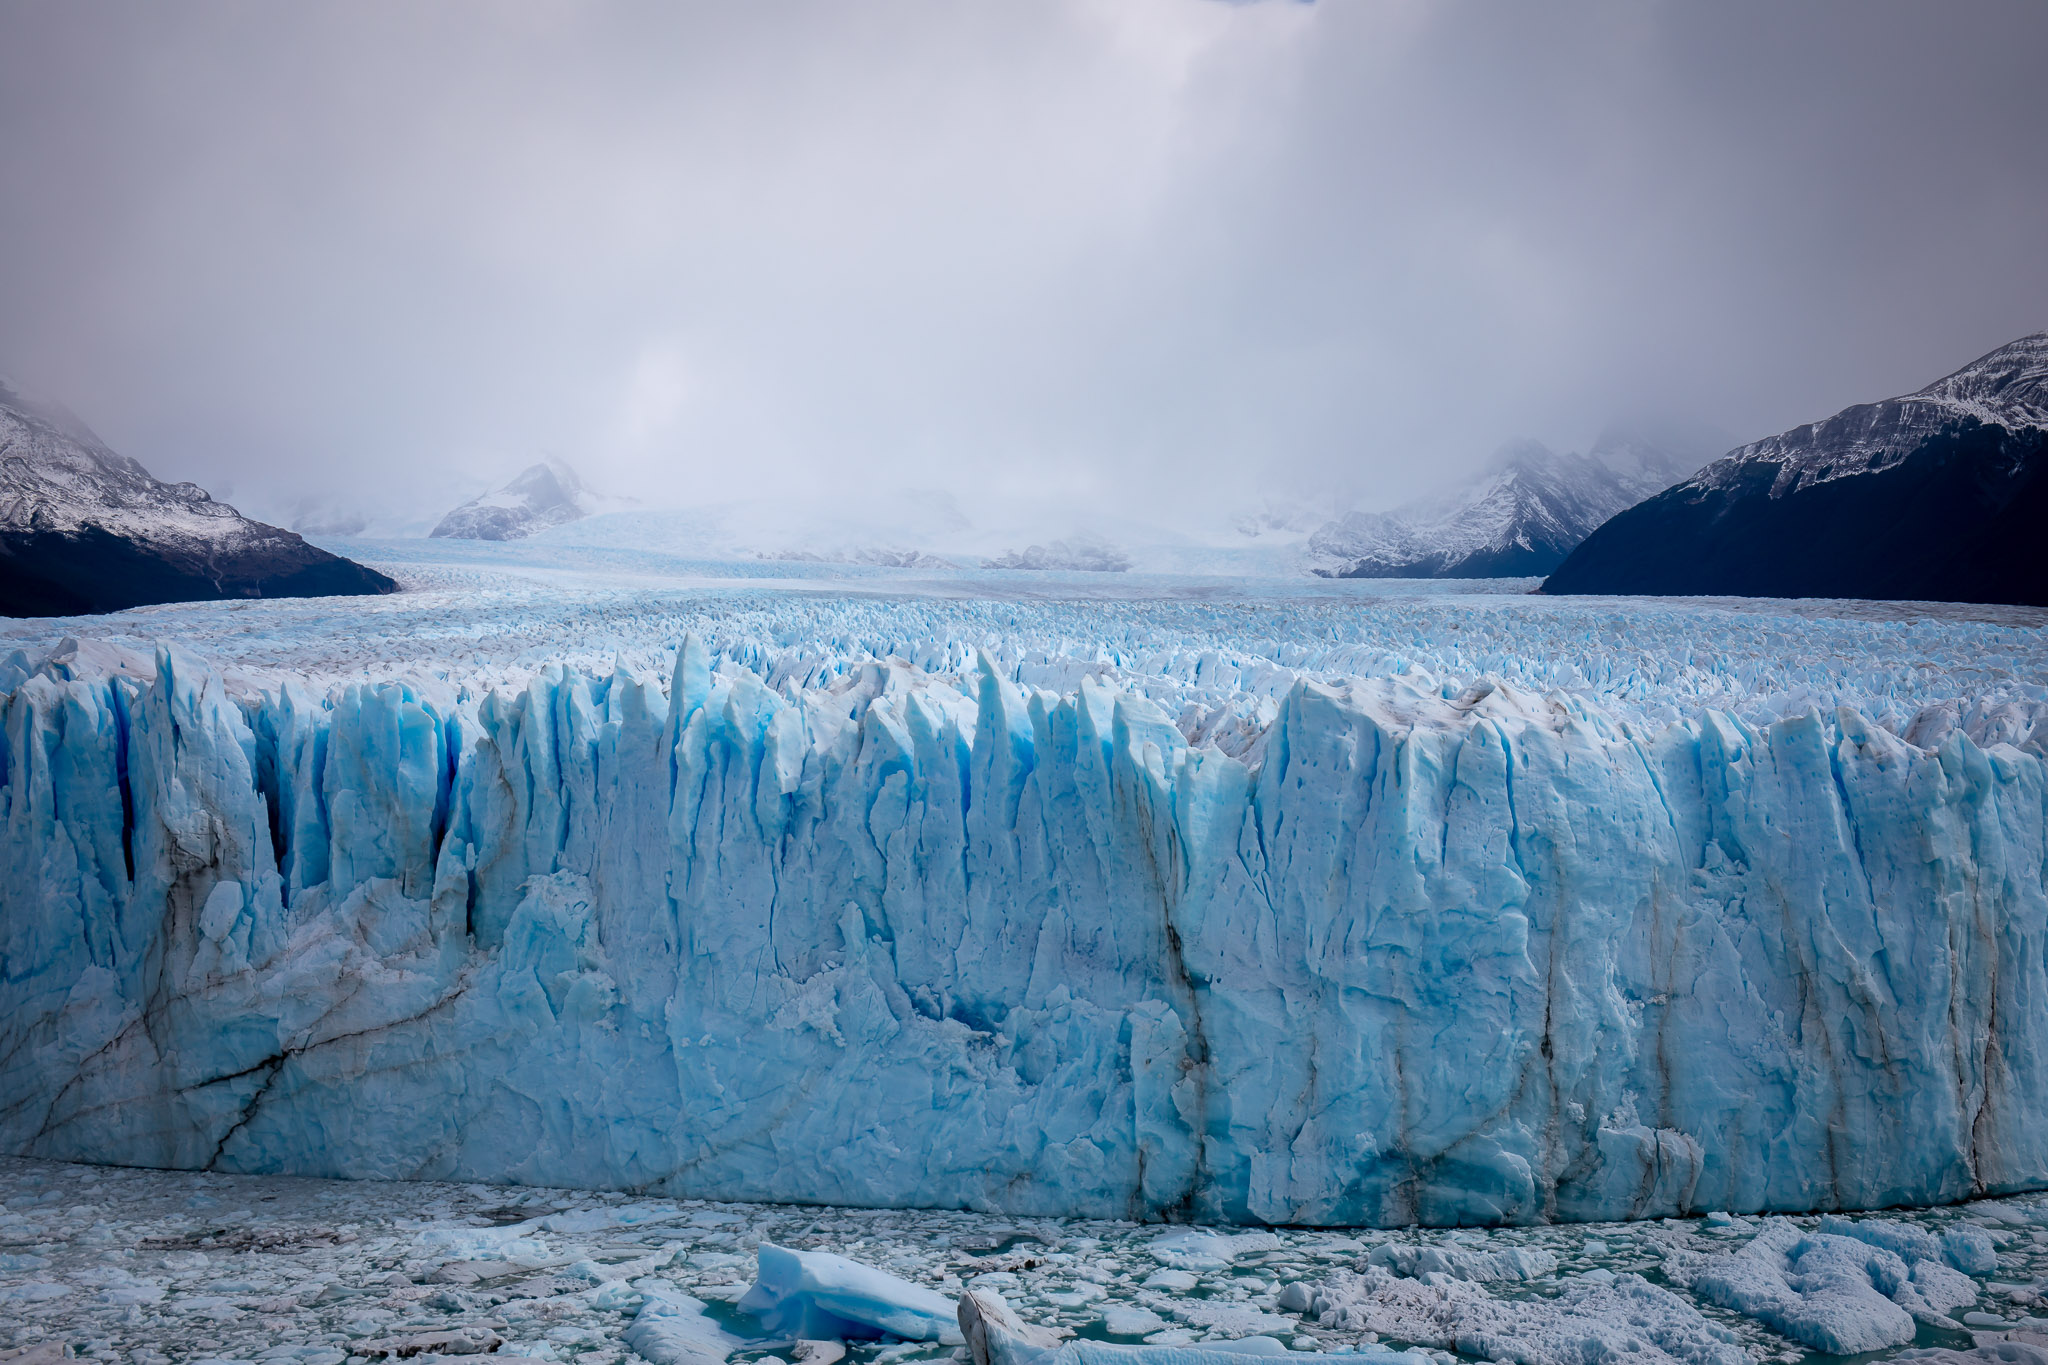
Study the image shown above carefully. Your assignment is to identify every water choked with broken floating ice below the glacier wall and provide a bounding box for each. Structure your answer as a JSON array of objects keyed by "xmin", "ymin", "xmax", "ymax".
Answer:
[{"xmin": 12, "ymin": 1158, "xmax": 2048, "ymax": 1365}]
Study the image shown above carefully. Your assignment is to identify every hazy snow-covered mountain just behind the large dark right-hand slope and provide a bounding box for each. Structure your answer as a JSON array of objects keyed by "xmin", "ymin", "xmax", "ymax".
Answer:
[{"xmin": 1309, "ymin": 430, "xmax": 1704, "ymax": 579}]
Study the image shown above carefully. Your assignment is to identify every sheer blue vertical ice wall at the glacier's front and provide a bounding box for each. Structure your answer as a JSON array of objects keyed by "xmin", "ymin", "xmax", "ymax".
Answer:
[{"xmin": 0, "ymin": 639, "xmax": 2048, "ymax": 1227}]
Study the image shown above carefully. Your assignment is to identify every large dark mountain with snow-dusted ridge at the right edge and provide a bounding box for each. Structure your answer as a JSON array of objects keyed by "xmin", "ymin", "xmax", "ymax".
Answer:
[{"xmin": 1544, "ymin": 332, "xmax": 2048, "ymax": 606}]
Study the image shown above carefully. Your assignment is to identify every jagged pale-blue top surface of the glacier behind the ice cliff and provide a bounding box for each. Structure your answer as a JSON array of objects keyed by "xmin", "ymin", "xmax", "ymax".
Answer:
[{"xmin": 0, "ymin": 540, "xmax": 2048, "ymax": 739}]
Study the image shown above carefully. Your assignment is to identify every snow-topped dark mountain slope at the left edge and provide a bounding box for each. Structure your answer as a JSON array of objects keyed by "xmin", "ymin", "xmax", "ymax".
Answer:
[{"xmin": 0, "ymin": 385, "xmax": 397, "ymax": 616}]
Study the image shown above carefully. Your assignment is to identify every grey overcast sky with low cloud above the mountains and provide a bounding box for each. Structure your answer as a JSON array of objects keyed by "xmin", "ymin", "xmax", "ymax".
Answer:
[{"xmin": 0, "ymin": 0, "xmax": 2048, "ymax": 516}]
